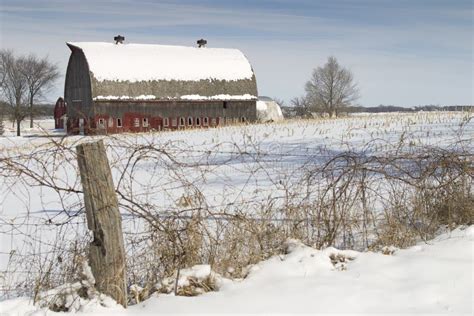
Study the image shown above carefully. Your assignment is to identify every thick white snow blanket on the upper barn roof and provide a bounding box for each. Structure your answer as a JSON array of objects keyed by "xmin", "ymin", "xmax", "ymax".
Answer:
[{"xmin": 67, "ymin": 42, "xmax": 253, "ymax": 82}]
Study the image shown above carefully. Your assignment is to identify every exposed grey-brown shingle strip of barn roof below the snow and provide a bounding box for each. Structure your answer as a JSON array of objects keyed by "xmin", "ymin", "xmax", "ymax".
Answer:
[{"xmin": 91, "ymin": 74, "xmax": 258, "ymax": 99}]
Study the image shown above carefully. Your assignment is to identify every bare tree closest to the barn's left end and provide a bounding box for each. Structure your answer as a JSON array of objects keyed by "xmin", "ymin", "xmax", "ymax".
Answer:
[{"xmin": 22, "ymin": 55, "xmax": 59, "ymax": 128}]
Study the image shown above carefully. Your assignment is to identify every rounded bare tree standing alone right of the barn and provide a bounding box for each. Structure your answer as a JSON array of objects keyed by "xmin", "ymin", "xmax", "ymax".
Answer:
[{"xmin": 305, "ymin": 56, "xmax": 359, "ymax": 117}]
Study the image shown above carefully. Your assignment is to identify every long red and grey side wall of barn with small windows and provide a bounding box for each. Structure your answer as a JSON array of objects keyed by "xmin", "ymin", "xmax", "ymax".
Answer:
[{"xmin": 70, "ymin": 101, "xmax": 257, "ymax": 134}]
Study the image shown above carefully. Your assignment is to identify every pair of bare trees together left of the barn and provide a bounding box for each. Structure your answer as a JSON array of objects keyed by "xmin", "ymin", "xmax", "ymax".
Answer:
[{"xmin": 0, "ymin": 49, "xmax": 59, "ymax": 136}]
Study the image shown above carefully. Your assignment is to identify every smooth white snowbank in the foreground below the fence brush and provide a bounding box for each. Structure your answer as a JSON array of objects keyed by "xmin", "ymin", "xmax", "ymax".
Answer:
[{"xmin": 0, "ymin": 226, "xmax": 474, "ymax": 316}]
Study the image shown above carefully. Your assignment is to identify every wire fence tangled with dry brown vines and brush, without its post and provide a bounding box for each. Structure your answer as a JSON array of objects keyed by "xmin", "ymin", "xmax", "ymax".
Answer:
[{"xmin": 0, "ymin": 118, "xmax": 474, "ymax": 298}]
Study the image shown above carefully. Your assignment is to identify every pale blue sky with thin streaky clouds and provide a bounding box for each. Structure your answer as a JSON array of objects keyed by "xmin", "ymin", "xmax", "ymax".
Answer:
[{"xmin": 0, "ymin": 0, "xmax": 474, "ymax": 107}]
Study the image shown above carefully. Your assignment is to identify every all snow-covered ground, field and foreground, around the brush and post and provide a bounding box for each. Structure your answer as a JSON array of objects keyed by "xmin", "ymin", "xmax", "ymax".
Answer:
[{"xmin": 0, "ymin": 112, "xmax": 474, "ymax": 315}]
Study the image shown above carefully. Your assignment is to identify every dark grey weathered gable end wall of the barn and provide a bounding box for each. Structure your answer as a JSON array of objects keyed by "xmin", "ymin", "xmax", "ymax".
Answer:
[{"xmin": 64, "ymin": 46, "xmax": 93, "ymax": 123}]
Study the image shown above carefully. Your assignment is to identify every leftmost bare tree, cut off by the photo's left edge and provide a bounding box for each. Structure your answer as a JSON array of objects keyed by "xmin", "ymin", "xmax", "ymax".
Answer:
[{"xmin": 0, "ymin": 50, "xmax": 27, "ymax": 136}]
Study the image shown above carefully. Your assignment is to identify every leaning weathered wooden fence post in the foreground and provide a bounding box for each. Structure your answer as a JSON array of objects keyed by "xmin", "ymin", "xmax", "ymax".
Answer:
[{"xmin": 76, "ymin": 141, "xmax": 127, "ymax": 307}]
